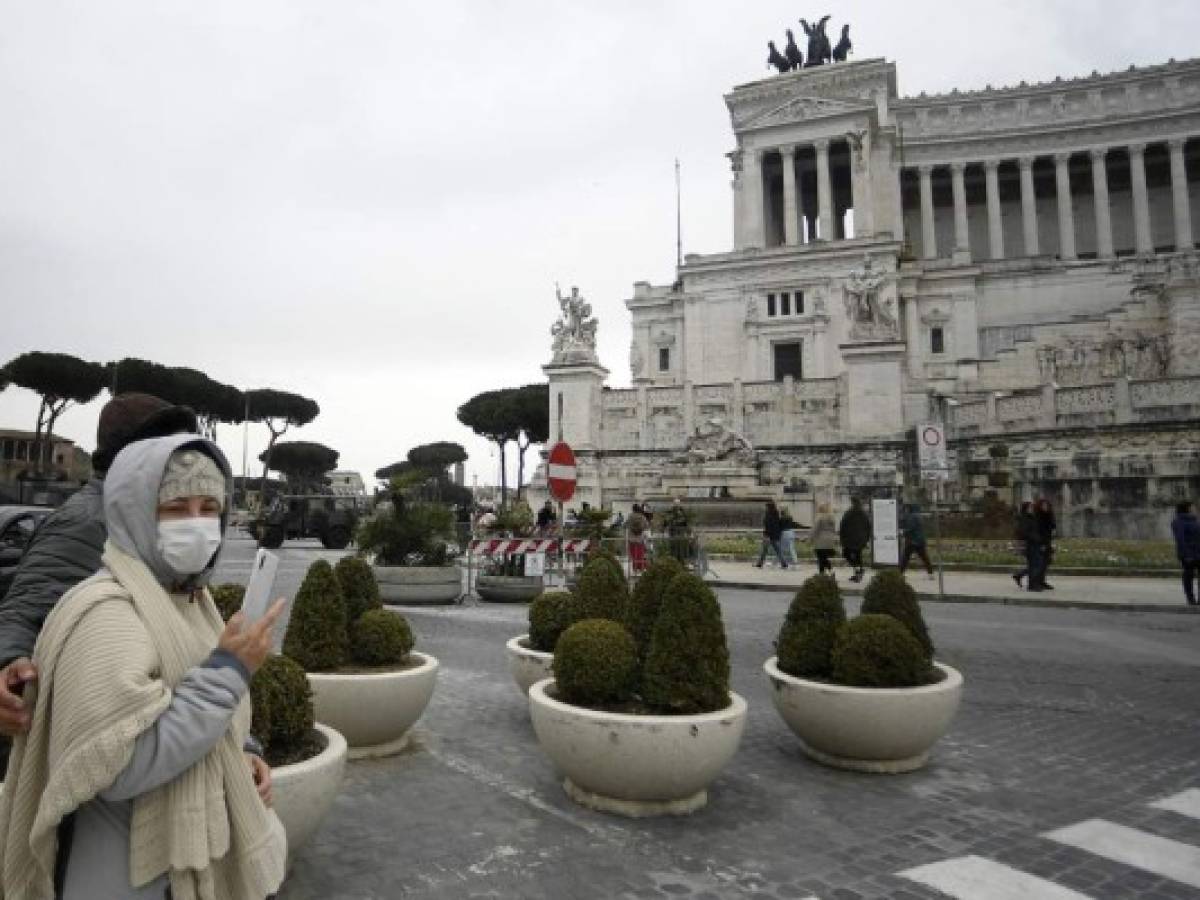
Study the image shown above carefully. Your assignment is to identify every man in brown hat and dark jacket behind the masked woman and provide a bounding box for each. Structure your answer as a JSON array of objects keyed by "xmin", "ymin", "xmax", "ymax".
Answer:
[{"xmin": 0, "ymin": 394, "xmax": 197, "ymax": 753}]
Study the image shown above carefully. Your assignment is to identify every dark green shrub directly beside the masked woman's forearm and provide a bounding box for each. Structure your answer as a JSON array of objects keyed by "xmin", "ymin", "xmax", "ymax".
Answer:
[{"xmin": 250, "ymin": 655, "xmax": 313, "ymax": 766}]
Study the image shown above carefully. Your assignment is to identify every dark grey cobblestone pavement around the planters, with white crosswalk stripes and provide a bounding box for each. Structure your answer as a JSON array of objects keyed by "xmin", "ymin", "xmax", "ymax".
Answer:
[{"xmin": 260, "ymin": 564, "xmax": 1200, "ymax": 900}]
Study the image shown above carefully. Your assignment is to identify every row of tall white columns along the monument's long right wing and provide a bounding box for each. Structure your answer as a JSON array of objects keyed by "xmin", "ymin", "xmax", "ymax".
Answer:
[{"xmin": 917, "ymin": 138, "xmax": 1194, "ymax": 259}]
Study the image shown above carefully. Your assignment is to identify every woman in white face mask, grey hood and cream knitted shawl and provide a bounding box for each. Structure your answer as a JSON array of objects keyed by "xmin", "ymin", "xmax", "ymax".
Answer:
[{"xmin": 0, "ymin": 434, "xmax": 287, "ymax": 900}]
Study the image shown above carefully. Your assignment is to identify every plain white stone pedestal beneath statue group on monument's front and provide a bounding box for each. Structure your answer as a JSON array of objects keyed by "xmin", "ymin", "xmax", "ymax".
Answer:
[{"xmin": 840, "ymin": 341, "xmax": 905, "ymax": 436}]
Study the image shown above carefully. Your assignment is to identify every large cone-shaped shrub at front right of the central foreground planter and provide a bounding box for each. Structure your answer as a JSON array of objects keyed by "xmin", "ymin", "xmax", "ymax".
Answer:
[{"xmin": 641, "ymin": 575, "xmax": 730, "ymax": 714}]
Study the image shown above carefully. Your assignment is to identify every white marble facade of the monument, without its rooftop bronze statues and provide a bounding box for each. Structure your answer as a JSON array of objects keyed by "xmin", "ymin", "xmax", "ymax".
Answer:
[{"xmin": 546, "ymin": 59, "xmax": 1200, "ymax": 535}]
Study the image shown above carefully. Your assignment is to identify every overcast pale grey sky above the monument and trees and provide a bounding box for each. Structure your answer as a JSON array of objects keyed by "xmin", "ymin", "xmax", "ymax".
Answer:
[{"xmin": 0, "ymin": 0, "xmax": 1200, "ymax": 494}]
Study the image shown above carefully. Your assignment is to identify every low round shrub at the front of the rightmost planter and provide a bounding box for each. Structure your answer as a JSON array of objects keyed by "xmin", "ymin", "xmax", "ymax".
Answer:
[{"xmin": 830, "ymin": 614, "xmax": 930, "ymax": 688}]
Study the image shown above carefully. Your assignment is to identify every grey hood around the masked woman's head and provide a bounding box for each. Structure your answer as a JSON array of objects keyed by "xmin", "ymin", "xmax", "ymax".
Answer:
[{"xmin": 104, "ymin": 434, "xmax": 233, "ymax": 589}]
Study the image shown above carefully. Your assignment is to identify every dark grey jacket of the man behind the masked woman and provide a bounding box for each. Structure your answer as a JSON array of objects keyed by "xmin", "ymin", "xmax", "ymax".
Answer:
[{"xmin": 0, "ymin": 478, "xmax": 106, "ymax": 666}]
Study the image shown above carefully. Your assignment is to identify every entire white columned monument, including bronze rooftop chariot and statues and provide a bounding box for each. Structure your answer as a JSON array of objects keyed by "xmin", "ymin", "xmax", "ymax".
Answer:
[{"xmin": 534, "ymin": 17, "xmax": 1200, "ymax": 536}]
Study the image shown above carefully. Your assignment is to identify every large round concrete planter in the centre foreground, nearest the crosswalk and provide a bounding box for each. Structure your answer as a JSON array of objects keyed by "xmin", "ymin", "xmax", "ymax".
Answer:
[{"xmin": 529, "ymin": 678, "xmax": 746, "ymax": 816}]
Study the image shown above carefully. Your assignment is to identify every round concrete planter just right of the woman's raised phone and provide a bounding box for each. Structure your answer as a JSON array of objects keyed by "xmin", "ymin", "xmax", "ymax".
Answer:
[{"xmin": 308, "ymin": 653, "xmax": 438, "ymax": 760}]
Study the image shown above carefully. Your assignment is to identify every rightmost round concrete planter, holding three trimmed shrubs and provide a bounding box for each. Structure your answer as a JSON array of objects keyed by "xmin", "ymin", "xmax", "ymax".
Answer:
[{"xmin": 763, "ymin": 656, "xmax": 962, "ymax": 774}]
